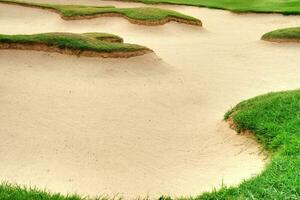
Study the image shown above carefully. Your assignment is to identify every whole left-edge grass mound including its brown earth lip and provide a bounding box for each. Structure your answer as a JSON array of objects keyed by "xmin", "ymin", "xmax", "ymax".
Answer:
[{"xmin": 0, "ymin": 33, "xmax": 152, "ymax": 58}]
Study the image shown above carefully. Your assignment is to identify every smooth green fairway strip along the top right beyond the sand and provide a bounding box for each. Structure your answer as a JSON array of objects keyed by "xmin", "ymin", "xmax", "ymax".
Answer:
[{"xmin": 119, "ymin": 0, "xmax": 300, "ymax": 15}]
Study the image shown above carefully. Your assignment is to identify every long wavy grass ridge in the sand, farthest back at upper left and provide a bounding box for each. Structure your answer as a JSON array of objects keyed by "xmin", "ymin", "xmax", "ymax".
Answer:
[{"xmin": 0, "ymin": 0, "xmax": 201, "ymax": 25}]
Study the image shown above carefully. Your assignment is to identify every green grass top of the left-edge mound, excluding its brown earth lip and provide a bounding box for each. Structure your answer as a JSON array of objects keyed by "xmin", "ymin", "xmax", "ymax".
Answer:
[{"xmin": 0, "ymin": 33, "xmax": 149, "ymax": 52}]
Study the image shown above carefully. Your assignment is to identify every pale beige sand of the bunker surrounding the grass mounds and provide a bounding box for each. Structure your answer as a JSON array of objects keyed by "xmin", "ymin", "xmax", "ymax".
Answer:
[{"xmin": 0, "ymin": 0, "xmax": 300, "ymax": 198}]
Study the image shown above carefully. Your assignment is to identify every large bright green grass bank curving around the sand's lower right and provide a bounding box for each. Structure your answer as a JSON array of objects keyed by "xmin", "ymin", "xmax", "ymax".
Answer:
[{"xmin": 184, "ymin": 90, "xmax": 300, "ymax": 200}]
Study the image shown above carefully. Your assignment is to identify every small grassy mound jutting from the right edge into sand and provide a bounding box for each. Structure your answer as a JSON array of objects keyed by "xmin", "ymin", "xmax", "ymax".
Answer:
[{"xmin": 262, "ymin": 27, "xmax": 300, "ymax": 42}]
